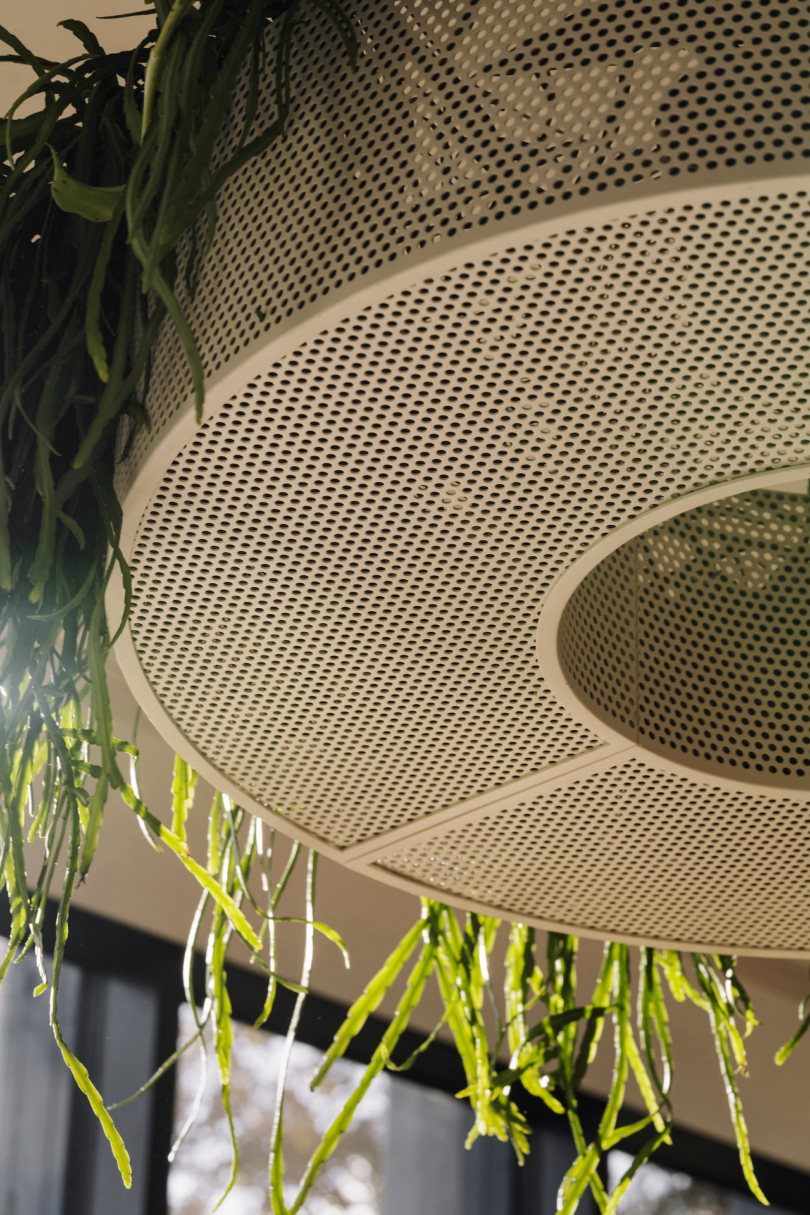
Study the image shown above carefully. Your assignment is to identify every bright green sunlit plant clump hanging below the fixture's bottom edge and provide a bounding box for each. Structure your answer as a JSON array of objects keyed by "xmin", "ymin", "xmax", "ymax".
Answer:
[{"xmin": 270, "ymin": 899, "xmax": 766, "ymax": 1215}]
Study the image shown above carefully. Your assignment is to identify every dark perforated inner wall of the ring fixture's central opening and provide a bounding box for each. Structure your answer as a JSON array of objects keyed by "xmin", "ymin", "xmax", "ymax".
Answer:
[{"xmin": 557, "ymin": 479, "xmax": 810, "ymax": 791}]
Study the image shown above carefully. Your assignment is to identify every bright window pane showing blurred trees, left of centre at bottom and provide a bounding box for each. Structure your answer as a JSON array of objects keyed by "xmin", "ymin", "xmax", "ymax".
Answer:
[{"xmin": 169, "ymin": 1006, "xmax": 514, "ymax": 1215}]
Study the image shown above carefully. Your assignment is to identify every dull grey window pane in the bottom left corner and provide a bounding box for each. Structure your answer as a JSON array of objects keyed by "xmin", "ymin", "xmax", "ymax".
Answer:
[{"xmin": 0, "ymin": 937, "xmax": 158, "ymax": 1215}]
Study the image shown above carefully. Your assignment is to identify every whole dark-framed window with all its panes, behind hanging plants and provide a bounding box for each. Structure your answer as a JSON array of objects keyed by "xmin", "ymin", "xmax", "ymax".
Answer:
[{"xmin": 0, "ymin": 906, "xmax": 810, "ymax": 1215}]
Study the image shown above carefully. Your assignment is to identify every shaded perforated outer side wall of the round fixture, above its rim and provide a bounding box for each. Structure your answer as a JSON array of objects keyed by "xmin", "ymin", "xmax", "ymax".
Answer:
[{"xmin": 118, "ymin": 0, "xmax": 810, "ymax": 498}]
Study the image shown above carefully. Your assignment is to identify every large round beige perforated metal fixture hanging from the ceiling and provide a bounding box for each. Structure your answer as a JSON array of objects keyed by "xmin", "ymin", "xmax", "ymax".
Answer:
[{"xmin": 112, "ymin": 0, "xmax": 810, "ymax": 955}]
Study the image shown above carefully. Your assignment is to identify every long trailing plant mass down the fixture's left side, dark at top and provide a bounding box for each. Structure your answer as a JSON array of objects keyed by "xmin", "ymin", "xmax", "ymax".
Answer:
[{"xmin": 0, "ymin": 0, "xmax": 357, "ymax": 1185}]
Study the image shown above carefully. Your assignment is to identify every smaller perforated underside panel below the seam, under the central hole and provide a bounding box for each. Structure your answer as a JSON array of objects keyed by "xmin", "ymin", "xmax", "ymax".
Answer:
[{"xmin": 378, "ymin": 759, "xmax": 810, "ymax": 951}]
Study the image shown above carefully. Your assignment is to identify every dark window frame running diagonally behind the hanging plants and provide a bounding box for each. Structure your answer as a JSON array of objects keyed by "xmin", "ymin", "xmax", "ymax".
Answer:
[{"xmin": 0, "ymin": 899, "xmax": 810, "ymax": 1215}]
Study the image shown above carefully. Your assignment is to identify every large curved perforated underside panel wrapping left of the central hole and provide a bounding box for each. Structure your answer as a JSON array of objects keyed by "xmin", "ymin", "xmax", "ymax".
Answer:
[{"xmin": 131, "ymin": 192, "xmax": 810, "ymax": 847}]
